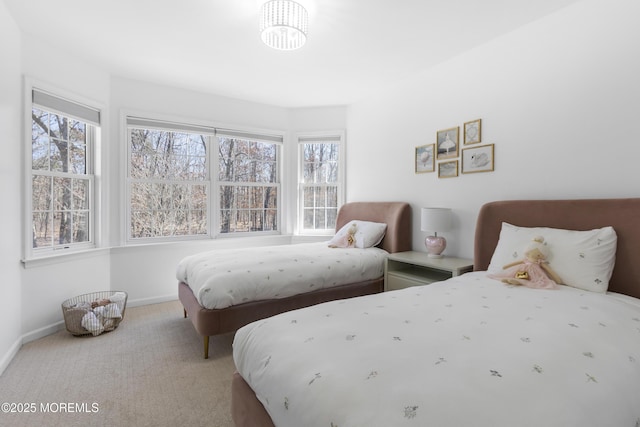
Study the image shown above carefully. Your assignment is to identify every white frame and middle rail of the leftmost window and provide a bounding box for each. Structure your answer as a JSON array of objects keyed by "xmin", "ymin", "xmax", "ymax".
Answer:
[{"xmin": 22, "ymin": 81, "xmax": 105, "ymax": 262}]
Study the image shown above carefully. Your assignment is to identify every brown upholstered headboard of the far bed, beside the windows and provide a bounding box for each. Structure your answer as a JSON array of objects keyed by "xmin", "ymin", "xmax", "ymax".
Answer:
[{"xmin": 336, "ymin": 202, "xmax": 411, "ymax": 253}]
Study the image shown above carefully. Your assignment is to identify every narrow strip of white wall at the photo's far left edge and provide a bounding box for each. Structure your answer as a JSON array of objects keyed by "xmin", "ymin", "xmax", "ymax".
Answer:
[{"xmin": 0, "ymin": 1, "xmax": 22, "ymax": 373}]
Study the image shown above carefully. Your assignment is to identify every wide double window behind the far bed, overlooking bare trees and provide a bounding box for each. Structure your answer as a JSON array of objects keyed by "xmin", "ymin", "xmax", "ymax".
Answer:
[{"xmin": 127, "ymin": 117, "xmax": 282, "ymax": 240}]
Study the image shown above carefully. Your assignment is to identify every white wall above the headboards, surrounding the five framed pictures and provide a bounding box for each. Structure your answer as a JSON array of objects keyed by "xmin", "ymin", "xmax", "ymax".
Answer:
[{"xmin": 347, "ymin": 0, "xmax": 640, "ymax": 257}]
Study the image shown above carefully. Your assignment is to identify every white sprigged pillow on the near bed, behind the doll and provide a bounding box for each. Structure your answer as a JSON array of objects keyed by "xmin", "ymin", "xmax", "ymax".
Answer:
[{"xmin": 487, "ymin": 222, "xmax": 618, "ymax": 292}]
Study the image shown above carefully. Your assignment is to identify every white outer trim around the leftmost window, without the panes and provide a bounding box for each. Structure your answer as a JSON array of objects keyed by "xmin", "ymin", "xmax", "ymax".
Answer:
[{"xmin": 22, "ymin": 76, "xmax": 108, "ymax": 265}]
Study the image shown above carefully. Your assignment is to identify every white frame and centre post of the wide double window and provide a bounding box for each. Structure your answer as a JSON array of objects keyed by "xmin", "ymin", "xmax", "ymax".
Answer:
[{"xmin": 121, "ymin": 111, "xmax": 285, "ymax": 245}]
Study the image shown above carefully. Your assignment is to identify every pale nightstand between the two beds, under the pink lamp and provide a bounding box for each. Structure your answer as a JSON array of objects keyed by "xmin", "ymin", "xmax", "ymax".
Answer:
[{"xmin": 384, "ymin": 251, "xmax": 473, "ymax": 291}]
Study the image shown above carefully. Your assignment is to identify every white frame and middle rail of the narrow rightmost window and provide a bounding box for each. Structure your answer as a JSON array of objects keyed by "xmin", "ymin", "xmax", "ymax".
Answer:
[{"xmin": 295, "ymin": 130, "xmax": 346, "ymax": 236}]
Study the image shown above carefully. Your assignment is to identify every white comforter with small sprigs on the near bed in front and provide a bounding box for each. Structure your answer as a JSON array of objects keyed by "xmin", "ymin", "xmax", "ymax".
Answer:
[{"xmin": 233, "ymin": 272, "xmax": 640, "ymax": 427}]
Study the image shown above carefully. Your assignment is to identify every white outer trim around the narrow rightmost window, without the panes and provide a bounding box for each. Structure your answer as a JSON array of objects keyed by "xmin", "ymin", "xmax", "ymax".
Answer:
[{"xmin": 295, "ymin": 130, "xmax": 346, "ymax": 236}]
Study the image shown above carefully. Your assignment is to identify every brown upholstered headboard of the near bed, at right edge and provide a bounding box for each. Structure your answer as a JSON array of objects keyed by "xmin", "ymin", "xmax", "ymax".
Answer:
[{"xmin": 474, "ymin": 198, "xmax": 640, "ymax": 298}]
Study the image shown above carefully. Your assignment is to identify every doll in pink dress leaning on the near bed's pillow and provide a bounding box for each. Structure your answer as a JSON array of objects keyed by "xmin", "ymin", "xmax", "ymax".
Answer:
[{"xmin": 489, "ymin": 236, "xmax": 562, "ymax": 289}]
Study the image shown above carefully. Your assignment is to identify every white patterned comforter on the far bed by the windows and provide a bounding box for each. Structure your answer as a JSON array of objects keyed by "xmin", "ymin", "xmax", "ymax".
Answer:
[{"xmin": 176, "ymin": 242, "xmax": 388, "ymax": 309}]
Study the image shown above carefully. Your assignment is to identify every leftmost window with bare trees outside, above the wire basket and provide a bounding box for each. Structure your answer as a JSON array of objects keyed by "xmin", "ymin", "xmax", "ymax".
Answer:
[{"xmin": 28, "ymin": 89, "xmax": 100, "ymax": 257}]
